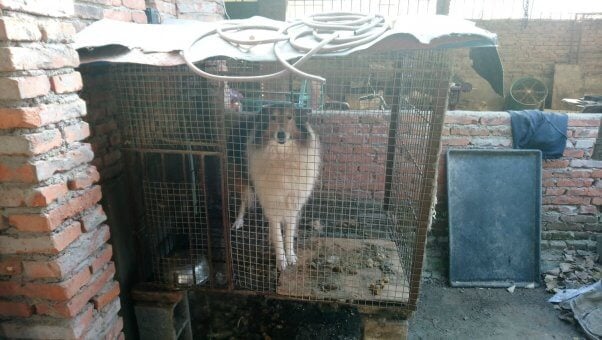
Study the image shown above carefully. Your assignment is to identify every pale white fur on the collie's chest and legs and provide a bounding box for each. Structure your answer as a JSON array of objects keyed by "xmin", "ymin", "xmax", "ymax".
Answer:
[{"xmin": 233, "ymin": 123, "xmax": 320, "ymax": 271}]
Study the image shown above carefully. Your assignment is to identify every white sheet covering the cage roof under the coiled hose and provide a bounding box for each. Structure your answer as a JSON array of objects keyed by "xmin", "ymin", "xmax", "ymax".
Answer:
[{"xmin": 75, "ymin": 16, "xmax": 497, "ymax": 66}]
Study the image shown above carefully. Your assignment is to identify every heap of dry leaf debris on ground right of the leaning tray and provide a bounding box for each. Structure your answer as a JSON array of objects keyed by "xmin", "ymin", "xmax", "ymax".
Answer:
[{"xmin": 543, "ymin": 249, "xmax": 602, "ymax": 293}]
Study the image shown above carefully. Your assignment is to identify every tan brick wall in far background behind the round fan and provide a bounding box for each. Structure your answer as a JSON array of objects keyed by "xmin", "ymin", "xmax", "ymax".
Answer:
[{"xmin": 454, "ymin": 20, "xmax": 602, "ymax": 110}]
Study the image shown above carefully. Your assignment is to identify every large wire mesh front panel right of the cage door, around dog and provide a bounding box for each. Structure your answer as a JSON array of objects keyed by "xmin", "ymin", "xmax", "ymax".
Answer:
[{"xmin": 226, "ymin": 50, "xmax": 450, "ymax": 306}]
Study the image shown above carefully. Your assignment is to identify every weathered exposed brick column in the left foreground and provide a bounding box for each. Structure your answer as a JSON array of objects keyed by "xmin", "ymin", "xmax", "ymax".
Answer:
[{"xmin": 0, "ymin": 0, "xmax": 123, "ymax": 339}]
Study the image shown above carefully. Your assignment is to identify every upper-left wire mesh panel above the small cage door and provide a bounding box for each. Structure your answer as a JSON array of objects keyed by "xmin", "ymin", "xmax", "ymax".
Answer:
[{"xmin": 112, "ymin": 63, "xmax": 223, "ymax": 150}]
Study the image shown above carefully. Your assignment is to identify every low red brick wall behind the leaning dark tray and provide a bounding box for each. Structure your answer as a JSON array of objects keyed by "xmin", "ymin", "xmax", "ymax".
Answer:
[{"xmin": 426, "ymin": 111, "xmax": 602, "ymax": 276}]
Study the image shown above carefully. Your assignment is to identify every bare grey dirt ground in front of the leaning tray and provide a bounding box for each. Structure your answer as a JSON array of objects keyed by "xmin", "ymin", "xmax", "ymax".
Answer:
[{"xmin": 409, "ymin": 282, "xmax": 585, "ymax": 339}]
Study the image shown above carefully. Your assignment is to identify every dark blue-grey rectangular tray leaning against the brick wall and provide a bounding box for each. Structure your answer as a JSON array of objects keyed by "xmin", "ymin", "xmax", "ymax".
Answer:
[{"xmin": 447, "ymin": 150, "xmax": 541, "ymax": 287}]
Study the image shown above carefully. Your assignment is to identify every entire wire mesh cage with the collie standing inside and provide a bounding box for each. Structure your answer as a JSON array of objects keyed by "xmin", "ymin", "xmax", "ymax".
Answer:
[{"xmin": 112, "ymin": 49, "xmax": 450, "ymax": 310}]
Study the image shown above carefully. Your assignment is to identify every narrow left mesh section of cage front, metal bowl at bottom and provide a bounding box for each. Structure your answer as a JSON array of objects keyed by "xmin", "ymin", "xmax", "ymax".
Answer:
[{"xmin": 111, "ymin": 64, "xmax": 231, "ymax": 288}]
